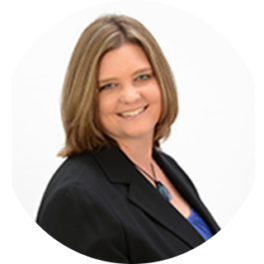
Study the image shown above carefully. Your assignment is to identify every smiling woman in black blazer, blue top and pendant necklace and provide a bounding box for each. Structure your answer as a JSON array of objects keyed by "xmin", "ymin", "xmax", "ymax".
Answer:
[{"xmin": 36, "ymin": 15, "xmax": 221, "ymax": 264}]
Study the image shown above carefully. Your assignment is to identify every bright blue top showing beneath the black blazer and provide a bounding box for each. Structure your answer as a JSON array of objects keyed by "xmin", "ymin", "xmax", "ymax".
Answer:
[{"xmin": 187, "ymin": 207, "xmax": 214, "ymax": 242}]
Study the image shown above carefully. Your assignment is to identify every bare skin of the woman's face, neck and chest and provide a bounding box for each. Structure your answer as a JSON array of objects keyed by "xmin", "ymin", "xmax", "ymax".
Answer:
[{"xmin": 98, "ymin": 44, "xmax": 191, "ymax": 217}]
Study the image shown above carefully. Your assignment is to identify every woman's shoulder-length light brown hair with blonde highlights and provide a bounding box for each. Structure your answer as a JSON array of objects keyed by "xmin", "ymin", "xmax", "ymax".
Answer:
[{"xmin": 57, "ymin": 14, "xmax": 178, "ymax": 157}]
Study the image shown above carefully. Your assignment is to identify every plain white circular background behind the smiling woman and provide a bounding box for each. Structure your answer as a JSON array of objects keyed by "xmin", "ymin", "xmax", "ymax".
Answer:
[{"xmin": 1, "ymin": 1, "xmax": 263, "ymax": 229}]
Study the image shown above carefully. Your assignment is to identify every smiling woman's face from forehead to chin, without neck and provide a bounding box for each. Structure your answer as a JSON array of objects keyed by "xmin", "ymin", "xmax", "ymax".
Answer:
[{"xmin": 98, "ymin": 43, "xmax": 162, "ymax": 145}]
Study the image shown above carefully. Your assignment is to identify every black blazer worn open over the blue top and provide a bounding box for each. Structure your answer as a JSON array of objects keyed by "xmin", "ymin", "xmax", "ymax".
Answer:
[{"xmin": 36, "ymin": 143, "xmax": 221, "ymax": 264}]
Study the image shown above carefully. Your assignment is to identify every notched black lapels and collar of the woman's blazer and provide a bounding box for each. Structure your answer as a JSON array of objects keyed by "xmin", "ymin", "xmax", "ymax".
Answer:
[{"xmin": 93, "ymin": 145, "xmax": 218, "ymax": 249}]
